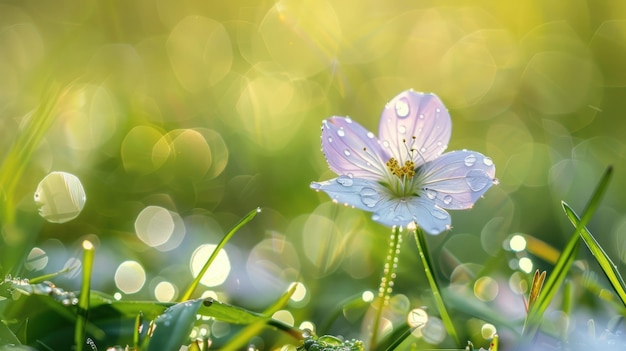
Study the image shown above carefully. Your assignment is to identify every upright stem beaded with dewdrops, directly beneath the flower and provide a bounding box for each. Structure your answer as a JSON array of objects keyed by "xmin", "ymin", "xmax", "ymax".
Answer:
[{"xmin": 369, "ymin": 227, "xmax": 402, "ymax": 350}]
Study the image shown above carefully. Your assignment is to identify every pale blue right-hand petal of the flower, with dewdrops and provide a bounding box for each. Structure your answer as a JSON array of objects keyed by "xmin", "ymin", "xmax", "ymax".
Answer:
[{"xmin": 416, "ymin": 150, "xmax": 496, "ymax": 210}]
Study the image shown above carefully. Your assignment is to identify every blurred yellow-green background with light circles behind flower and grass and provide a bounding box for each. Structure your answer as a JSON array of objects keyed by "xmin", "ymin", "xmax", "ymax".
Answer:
[{"xmin": 0, "ymin": 0, "xmax": 626, "ymax": 350}]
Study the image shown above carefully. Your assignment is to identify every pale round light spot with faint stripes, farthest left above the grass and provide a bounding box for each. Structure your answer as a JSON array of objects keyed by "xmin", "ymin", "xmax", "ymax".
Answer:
[{"xmin": 34, "ymin": 172, "xmax": 87, "ymax": 223}]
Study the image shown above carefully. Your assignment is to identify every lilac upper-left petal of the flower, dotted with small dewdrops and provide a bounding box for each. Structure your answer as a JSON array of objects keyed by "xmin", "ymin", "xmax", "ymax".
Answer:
[{"xmin": 322, "ymin": 117, "xmax": 386, "ymax": 180}]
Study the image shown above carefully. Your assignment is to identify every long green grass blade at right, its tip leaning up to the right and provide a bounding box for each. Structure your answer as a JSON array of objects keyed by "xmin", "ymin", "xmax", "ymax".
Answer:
[{"xmin": 522, "ymin": 167, "xmax": 613, "ymax": 340}]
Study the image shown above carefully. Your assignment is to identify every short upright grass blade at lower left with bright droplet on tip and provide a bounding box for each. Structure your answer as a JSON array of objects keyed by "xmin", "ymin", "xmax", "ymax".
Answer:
[{"xmin": 74, "ymin": 240, "xmax": 95, "ymax": 351}]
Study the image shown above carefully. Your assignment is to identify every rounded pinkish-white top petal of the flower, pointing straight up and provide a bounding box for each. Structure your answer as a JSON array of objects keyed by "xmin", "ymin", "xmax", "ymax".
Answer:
[{"xmin": 378, "ymin": 90, "xmax": 452, "ymax": 166}]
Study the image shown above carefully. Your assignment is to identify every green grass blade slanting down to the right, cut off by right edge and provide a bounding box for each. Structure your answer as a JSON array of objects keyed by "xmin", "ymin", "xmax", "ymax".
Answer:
[{"xmin": 563, "ymin": 202, "xmax": 626, "ymax": 306}]
